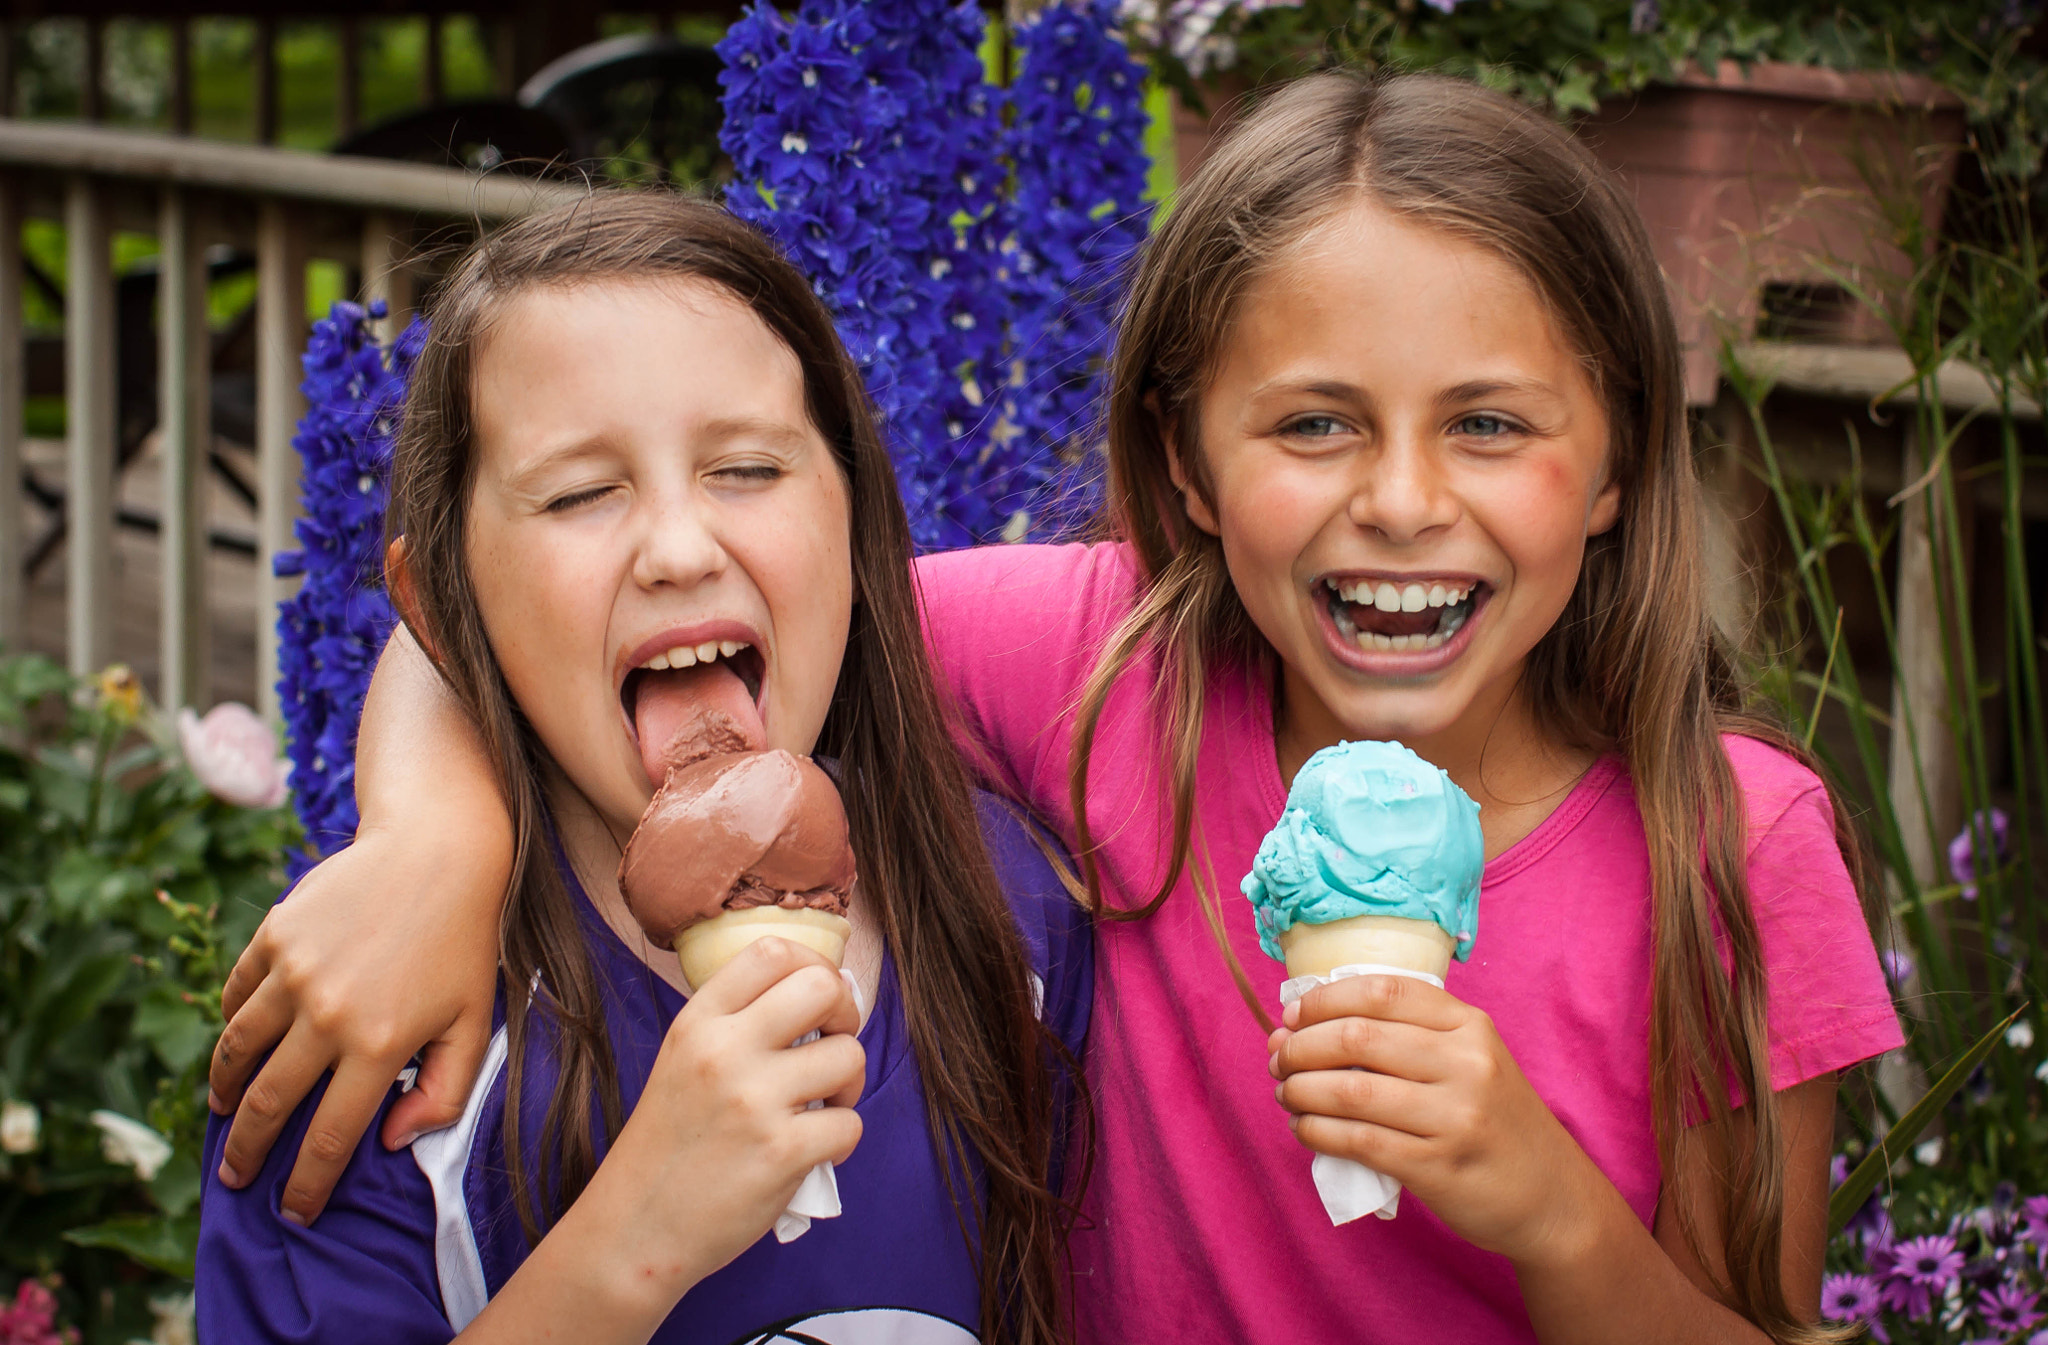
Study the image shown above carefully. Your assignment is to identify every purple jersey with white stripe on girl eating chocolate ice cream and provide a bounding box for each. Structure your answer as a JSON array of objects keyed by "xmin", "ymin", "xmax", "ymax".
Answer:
[{"xmin": 197, "ymin": 798, "xmax": 1094, "ymax": 1345}]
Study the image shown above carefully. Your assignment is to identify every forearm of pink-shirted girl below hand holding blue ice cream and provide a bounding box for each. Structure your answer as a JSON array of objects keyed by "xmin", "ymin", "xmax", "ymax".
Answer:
[{"xmin": 1516, "ymin": 1163, "xmax": 1769, "ymax": 1345}]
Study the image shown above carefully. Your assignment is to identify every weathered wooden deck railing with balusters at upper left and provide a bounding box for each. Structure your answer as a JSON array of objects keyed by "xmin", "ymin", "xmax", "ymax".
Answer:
[{"xmin": 0, "ymin": 119, "xmax": 582, "ymax": 717}]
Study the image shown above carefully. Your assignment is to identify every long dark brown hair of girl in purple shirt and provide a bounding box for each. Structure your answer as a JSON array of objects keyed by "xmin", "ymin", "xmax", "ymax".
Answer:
[{"xmin": 389, "ymin": 190, "xmax": 1085, "ymax": 1345}]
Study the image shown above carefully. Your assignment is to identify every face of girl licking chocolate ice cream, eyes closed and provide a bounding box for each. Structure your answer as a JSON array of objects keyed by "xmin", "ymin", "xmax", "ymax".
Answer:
[{"xmin": 467, "ymin": 280, "xmax": 854, "ymax": 835}]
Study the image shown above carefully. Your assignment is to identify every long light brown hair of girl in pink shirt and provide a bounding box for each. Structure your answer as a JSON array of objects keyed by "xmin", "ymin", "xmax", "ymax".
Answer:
[{"xmin": 1069, "ymin": 72, "xmax": 1862, "ymax": 1343}]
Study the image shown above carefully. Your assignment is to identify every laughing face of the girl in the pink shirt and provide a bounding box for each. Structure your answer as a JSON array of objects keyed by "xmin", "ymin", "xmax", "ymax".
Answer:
[{"xmin": 1176, "ymin": 203, "xmax": 1620, "ymax": 774}]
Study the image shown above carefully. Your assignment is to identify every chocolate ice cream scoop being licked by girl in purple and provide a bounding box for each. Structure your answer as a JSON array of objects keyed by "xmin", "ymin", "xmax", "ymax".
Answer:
[{"xmin": 618, "ymin": 725, "xmax": 854, "ymax": 948}]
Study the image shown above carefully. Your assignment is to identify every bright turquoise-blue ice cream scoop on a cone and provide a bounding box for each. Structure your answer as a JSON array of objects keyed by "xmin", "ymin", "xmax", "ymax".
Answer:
[{"xmin": 1241, "ymin": 743, "xmax": 1487, "ymax": 962}]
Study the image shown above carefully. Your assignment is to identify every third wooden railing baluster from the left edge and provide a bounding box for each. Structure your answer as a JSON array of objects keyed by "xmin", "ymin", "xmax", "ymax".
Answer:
[{"xmin": 158, "ymin": 186, "xmax": 213, "ymax": 710}]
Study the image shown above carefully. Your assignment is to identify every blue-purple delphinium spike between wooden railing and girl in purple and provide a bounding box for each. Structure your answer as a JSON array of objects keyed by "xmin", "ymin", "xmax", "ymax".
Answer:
[{"xmin": 274, "ymin": 301, "xmax": 426, "ymax": 878}]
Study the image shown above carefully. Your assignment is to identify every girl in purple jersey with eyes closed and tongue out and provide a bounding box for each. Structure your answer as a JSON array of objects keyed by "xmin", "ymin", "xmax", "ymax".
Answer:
[{"xmin": 197, "ymin": 192, "xmax": 1092, "ymax": 1345}]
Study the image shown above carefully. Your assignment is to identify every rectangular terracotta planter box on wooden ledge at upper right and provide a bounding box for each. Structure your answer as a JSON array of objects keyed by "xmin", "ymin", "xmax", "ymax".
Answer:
[{"xmin": 1577, "ymin": 61, "xmax": 1964, "ymax": 405}]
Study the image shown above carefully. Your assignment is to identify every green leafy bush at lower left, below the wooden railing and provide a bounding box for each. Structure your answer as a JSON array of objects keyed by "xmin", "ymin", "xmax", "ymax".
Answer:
[{"xmin": 0, "ymin": 655, "xmax": 297, "ymax": 1341}]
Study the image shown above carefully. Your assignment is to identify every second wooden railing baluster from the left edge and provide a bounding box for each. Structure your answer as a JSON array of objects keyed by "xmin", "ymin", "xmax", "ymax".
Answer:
[{"xmin": 63, "ymin": 176, "xmax": 115, "ymax": 674}]
